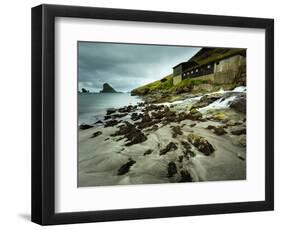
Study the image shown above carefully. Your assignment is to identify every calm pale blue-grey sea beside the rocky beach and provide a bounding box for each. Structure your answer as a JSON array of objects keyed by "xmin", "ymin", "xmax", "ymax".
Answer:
[{"xmin": 78, "ymin": 93, "xmax": 142, "ymax": 125}]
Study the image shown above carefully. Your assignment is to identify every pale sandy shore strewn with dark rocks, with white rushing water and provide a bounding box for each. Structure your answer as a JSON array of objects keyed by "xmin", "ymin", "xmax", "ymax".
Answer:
[{"xmin": 78, "ymin": 88, "xmax": 246, "ymax": 186}]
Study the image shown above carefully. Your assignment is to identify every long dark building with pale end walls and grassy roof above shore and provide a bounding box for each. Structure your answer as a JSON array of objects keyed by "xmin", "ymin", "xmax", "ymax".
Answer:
[{"xmin": 173, "ymin": 48, "xmax": 246, "ymax": 85}]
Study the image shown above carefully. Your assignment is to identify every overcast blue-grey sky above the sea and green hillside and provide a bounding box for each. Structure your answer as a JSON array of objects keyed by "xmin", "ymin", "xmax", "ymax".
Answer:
[{"xmin": 78, "ymin": 42, "xmax": 200, "ymax": 92}]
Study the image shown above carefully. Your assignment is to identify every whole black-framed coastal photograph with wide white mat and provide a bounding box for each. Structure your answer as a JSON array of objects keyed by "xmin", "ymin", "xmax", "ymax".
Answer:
[{"xmin": 32, "ymin": 5, "xmax": 274, "ymax": 225}]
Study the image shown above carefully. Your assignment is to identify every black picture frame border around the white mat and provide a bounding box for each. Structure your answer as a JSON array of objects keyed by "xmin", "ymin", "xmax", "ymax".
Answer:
[{"xmin": 31, "ymin": 5, "xmax": 274, "ymax": 225}]
